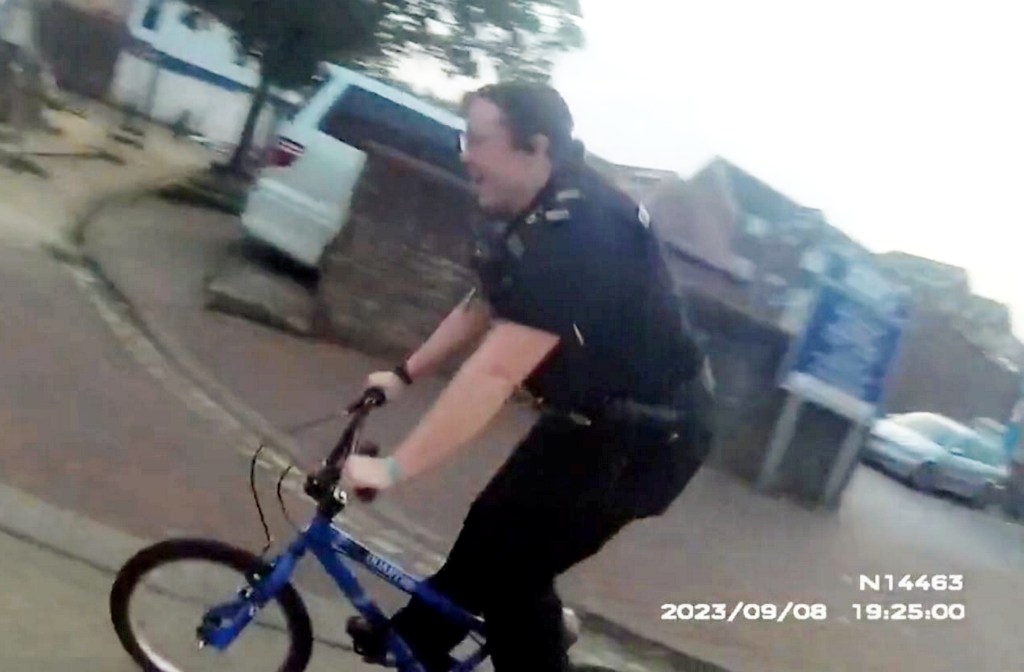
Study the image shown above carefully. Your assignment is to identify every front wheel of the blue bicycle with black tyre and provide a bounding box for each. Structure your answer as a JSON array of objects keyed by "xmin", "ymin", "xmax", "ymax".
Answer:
[{"xmin": 110, "ymin": 539, "xmax": 312, "ymax": 672}]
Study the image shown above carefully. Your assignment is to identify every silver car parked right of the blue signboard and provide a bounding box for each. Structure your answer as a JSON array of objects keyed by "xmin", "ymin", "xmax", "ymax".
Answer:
[{"xmin": 864, "ymin": 413, "xmax": 1010, "ymax": 507}]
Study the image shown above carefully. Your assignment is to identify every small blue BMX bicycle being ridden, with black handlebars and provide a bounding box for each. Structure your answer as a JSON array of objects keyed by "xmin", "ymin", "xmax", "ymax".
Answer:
[{"xmin": 110, "ymin": 389, "xmax": 593, "ymax": 672}]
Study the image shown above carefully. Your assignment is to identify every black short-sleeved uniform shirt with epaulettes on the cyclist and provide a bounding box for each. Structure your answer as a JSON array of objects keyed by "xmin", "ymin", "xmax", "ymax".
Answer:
[{"xmin": 476, "ymin": 164, "xmax": 702, "ymax": 411}]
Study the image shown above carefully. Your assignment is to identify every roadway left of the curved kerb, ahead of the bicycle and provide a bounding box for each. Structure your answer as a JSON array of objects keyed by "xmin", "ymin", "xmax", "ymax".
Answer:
[{"xmin": 0, "ymin": 236, "xmax": 356, "ymax": 671}]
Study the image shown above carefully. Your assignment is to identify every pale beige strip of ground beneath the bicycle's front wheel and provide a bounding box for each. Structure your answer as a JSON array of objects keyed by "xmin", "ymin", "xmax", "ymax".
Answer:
[{"xmin": 0, "ymin": 479, "xmax": 374, "ymax": 672}]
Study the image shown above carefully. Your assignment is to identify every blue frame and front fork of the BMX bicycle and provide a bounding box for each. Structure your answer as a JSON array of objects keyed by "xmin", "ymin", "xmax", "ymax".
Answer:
[{"xmin": 204, "ymin": 497, "xmax": 488, "ymax": 672}]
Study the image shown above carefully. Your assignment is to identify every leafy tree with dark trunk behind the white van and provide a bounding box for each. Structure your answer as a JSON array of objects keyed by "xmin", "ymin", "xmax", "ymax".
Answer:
[{"xmin": 185, "ymin": 0, "xmax": 583, "ymax": 172}]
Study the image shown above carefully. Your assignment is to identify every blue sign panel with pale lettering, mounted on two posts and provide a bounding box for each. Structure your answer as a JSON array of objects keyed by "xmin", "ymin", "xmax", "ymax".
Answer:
[{"xmin": 782, "ymin": 252, "xmax": 907, "ymax": 421}]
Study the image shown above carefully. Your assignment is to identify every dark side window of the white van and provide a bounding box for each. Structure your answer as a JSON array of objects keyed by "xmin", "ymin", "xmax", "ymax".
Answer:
[{"xmin": 319, "ymin": 86, "xmax": 465, "ymax": 177}]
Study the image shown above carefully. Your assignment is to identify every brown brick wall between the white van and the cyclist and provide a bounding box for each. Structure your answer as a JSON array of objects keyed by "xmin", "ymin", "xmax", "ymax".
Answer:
[{"xmin": 318, "ymin": 144, "xmax": 477, "ymax": 356}]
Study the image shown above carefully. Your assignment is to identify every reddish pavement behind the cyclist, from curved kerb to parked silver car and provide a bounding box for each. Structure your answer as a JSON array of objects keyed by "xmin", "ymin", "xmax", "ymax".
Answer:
[{"xmin": 79, "ymin": 190, "xmax": 1024, "ymax": 672}]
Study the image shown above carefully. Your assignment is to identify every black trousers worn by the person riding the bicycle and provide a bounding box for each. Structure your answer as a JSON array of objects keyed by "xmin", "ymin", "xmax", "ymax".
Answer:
[{"xmin": 392, "ymin": 399, "xmax": 710, "ymax": 672}]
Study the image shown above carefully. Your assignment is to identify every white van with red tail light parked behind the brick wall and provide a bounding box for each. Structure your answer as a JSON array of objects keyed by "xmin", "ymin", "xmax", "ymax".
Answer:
[{"xmin": 242, "ymin": 66, "xmax": 465, "ymax": 267}]
